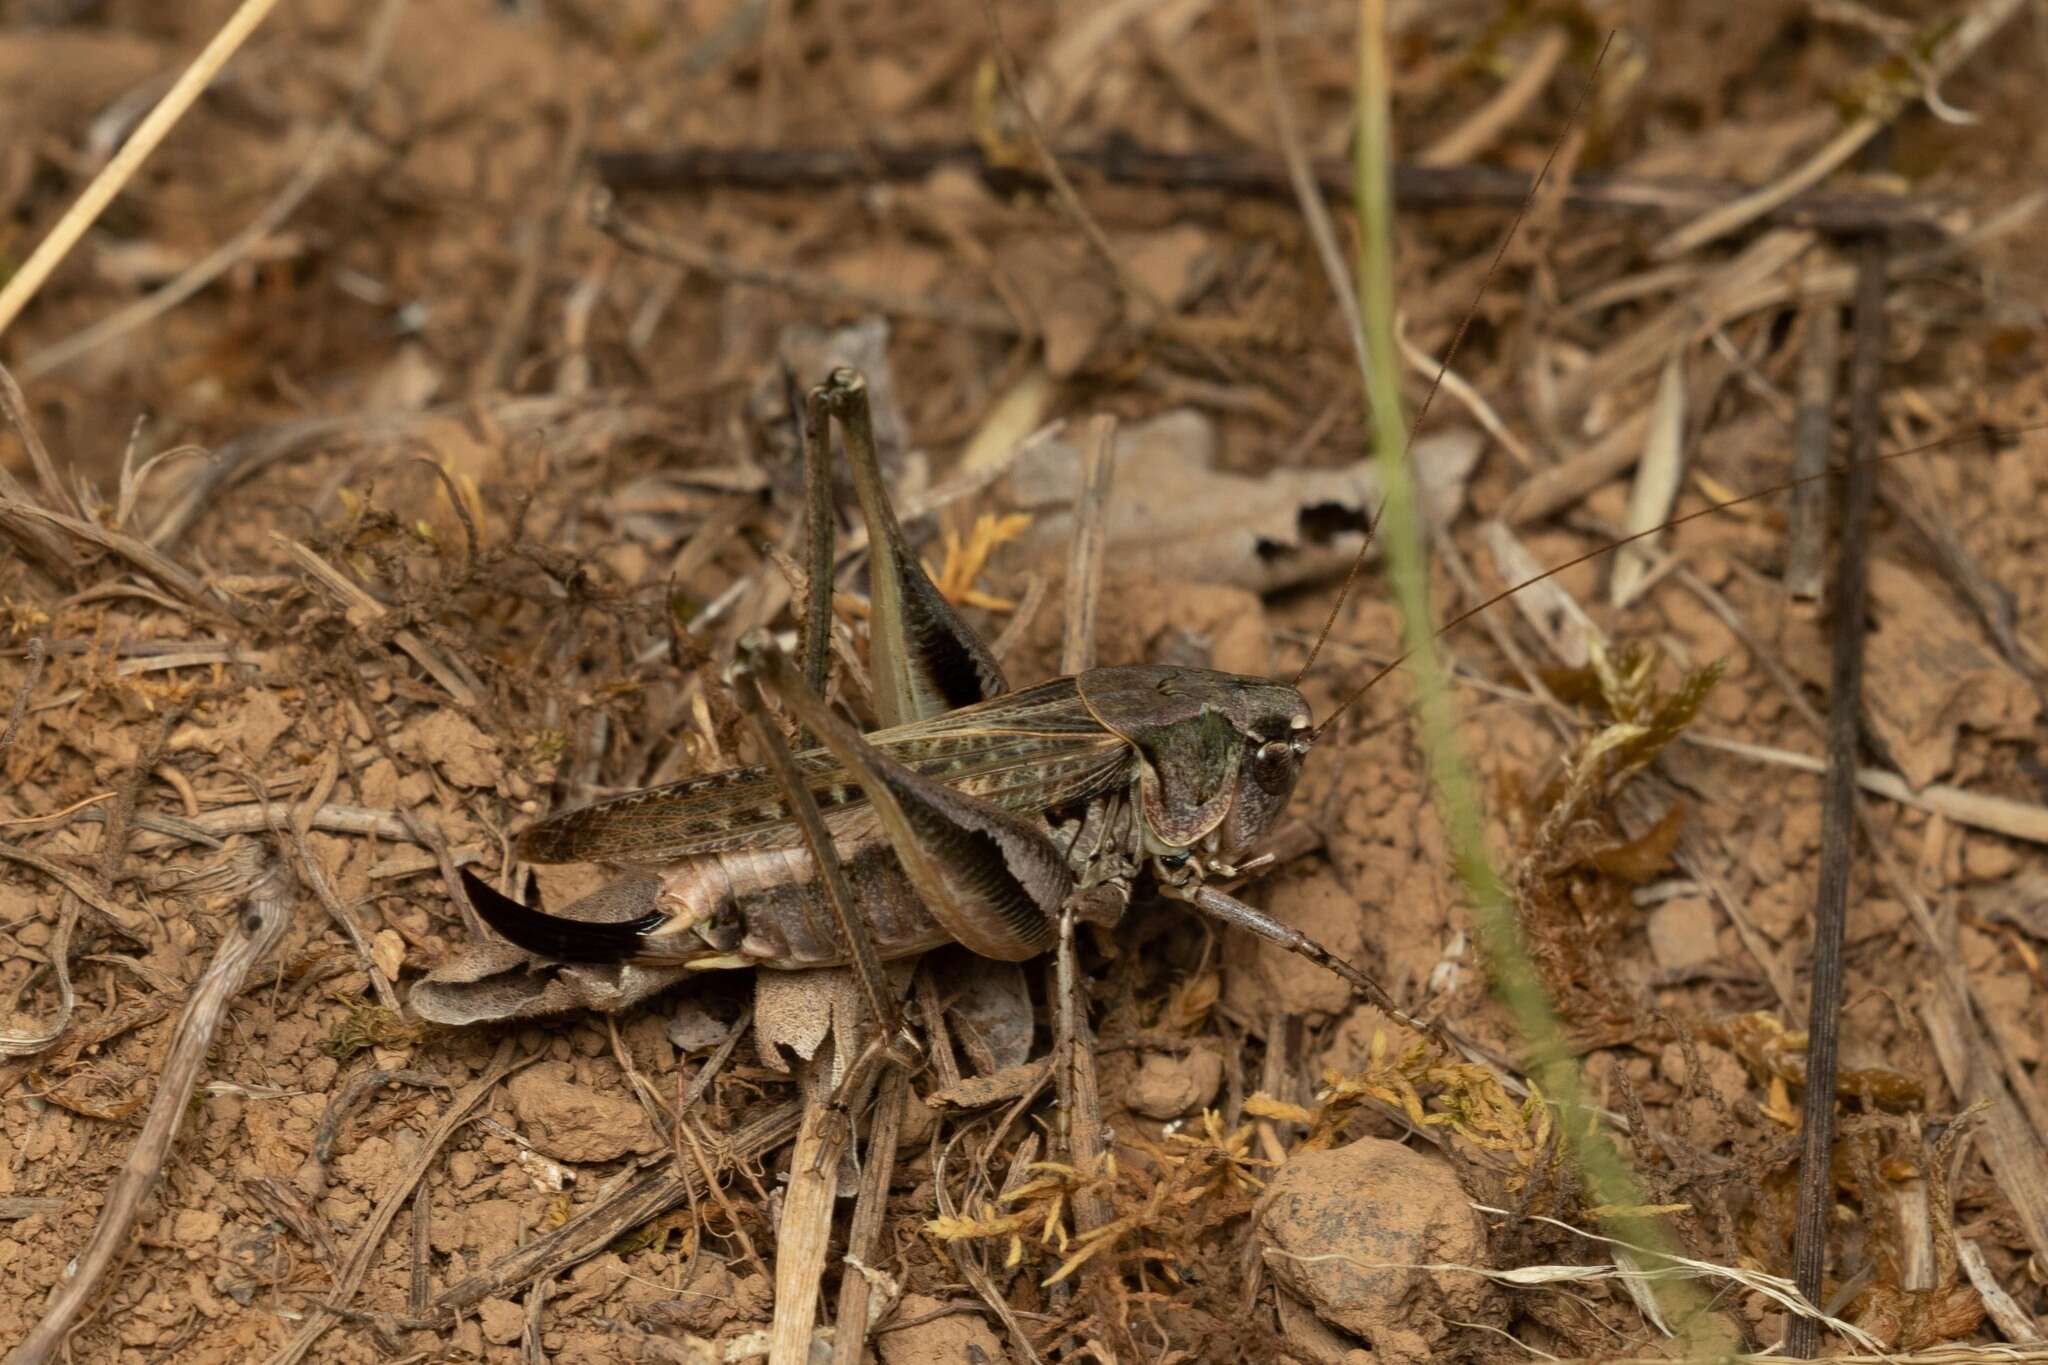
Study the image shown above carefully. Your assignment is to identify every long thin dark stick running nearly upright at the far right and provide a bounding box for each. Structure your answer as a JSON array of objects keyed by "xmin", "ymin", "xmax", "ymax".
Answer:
[{"xmin": 1786, "ymin": 237, "xmax": 1890, "ymax": 1359}]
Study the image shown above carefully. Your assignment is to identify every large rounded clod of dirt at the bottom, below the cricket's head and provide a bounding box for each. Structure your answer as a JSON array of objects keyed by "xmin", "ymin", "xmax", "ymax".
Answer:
[{"xmin": 1260, "ymin": 1138, "xmax": 1505, "ymax": 1365}]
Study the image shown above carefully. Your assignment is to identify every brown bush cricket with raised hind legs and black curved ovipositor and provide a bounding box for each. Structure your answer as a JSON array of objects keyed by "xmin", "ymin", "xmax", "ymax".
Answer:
[{"xmin": 442, "ymin": 368, "xmax": 1405, "ymax": 1088}]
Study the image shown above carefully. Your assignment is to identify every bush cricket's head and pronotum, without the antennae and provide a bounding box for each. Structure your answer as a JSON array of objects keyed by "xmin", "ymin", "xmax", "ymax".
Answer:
[{"xmin": 1077, "ymin": 665, "xmax": 1313, "ymax": 862}]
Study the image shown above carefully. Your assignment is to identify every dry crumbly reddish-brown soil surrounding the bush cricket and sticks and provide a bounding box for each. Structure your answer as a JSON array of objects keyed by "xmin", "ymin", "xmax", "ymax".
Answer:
[{"xmin": 0, "ymin": 0, "xmax": 2048, "ymax": 1365}]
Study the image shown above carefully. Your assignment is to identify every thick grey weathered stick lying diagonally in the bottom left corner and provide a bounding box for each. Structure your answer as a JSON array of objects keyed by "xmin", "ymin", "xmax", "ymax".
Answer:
[{"xmin": 8, "ymin": 862, "xmax": 295, "ymax": 1365}]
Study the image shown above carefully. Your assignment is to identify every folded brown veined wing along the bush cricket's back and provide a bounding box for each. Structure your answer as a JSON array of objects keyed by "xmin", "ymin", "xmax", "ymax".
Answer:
[{"xmin": 518, "ymin": 677, "xmax": 1133, "ymax": 864}]
